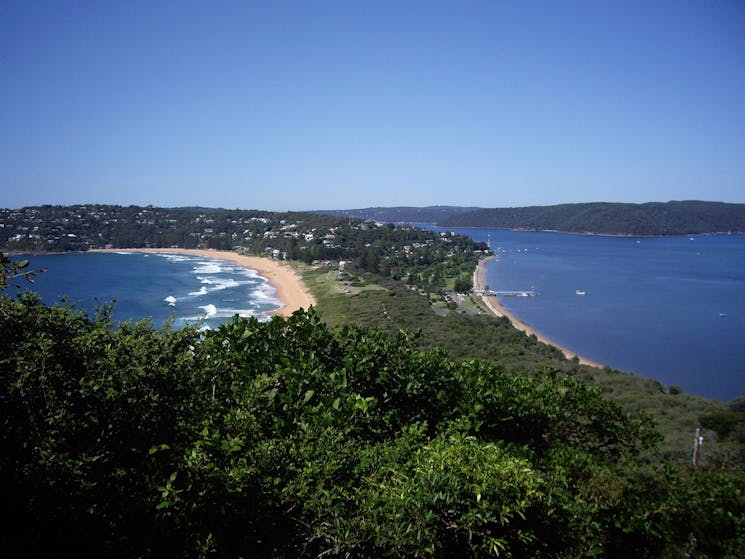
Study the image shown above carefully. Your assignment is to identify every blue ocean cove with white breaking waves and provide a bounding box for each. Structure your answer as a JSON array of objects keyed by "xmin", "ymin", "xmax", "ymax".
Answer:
[{"xmin": 18, "ymin": 251, "xmax": 282, "ymax": 328}]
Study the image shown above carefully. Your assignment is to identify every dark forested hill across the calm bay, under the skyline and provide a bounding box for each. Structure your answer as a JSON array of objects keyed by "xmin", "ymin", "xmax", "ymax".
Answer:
[{"xmin": 437, "ymin": 200, "xmax": 745, "ymax": 235}]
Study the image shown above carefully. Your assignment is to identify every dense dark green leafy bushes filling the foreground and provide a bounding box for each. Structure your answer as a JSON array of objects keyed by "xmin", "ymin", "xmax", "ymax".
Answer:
[{"xmin": 0, "ymin": 286, "xmax": 745, "ymax": 557}]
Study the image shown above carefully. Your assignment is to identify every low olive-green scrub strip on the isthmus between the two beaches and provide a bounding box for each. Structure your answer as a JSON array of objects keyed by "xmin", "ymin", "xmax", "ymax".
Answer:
[{"xmin": 296, "ymin": 264, "xmax": 741, "ymax": 465}]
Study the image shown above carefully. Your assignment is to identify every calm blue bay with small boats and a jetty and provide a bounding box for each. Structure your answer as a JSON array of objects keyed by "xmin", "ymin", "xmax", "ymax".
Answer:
[{"xmin": 422, "ymin": 226, "xmax": 745, "ymax": 401}]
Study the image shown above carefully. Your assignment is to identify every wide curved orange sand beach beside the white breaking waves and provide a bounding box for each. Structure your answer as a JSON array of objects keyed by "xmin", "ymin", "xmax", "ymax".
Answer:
[{"xmin": 88, "ymin": 248, "xmax": 316, "ymax": 316}]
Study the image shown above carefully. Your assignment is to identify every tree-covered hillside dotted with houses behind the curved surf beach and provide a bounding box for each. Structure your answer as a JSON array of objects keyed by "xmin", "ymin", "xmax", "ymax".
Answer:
[{"xmin": 0, "ymin": 204, "xmax": 487, "ymax": 298}]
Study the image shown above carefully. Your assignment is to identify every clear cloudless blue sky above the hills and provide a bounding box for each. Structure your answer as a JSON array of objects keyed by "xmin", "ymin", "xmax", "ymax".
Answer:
[{"xmin": 0, "ymin": 0, "xmax": 745, "ymax": 210}]
